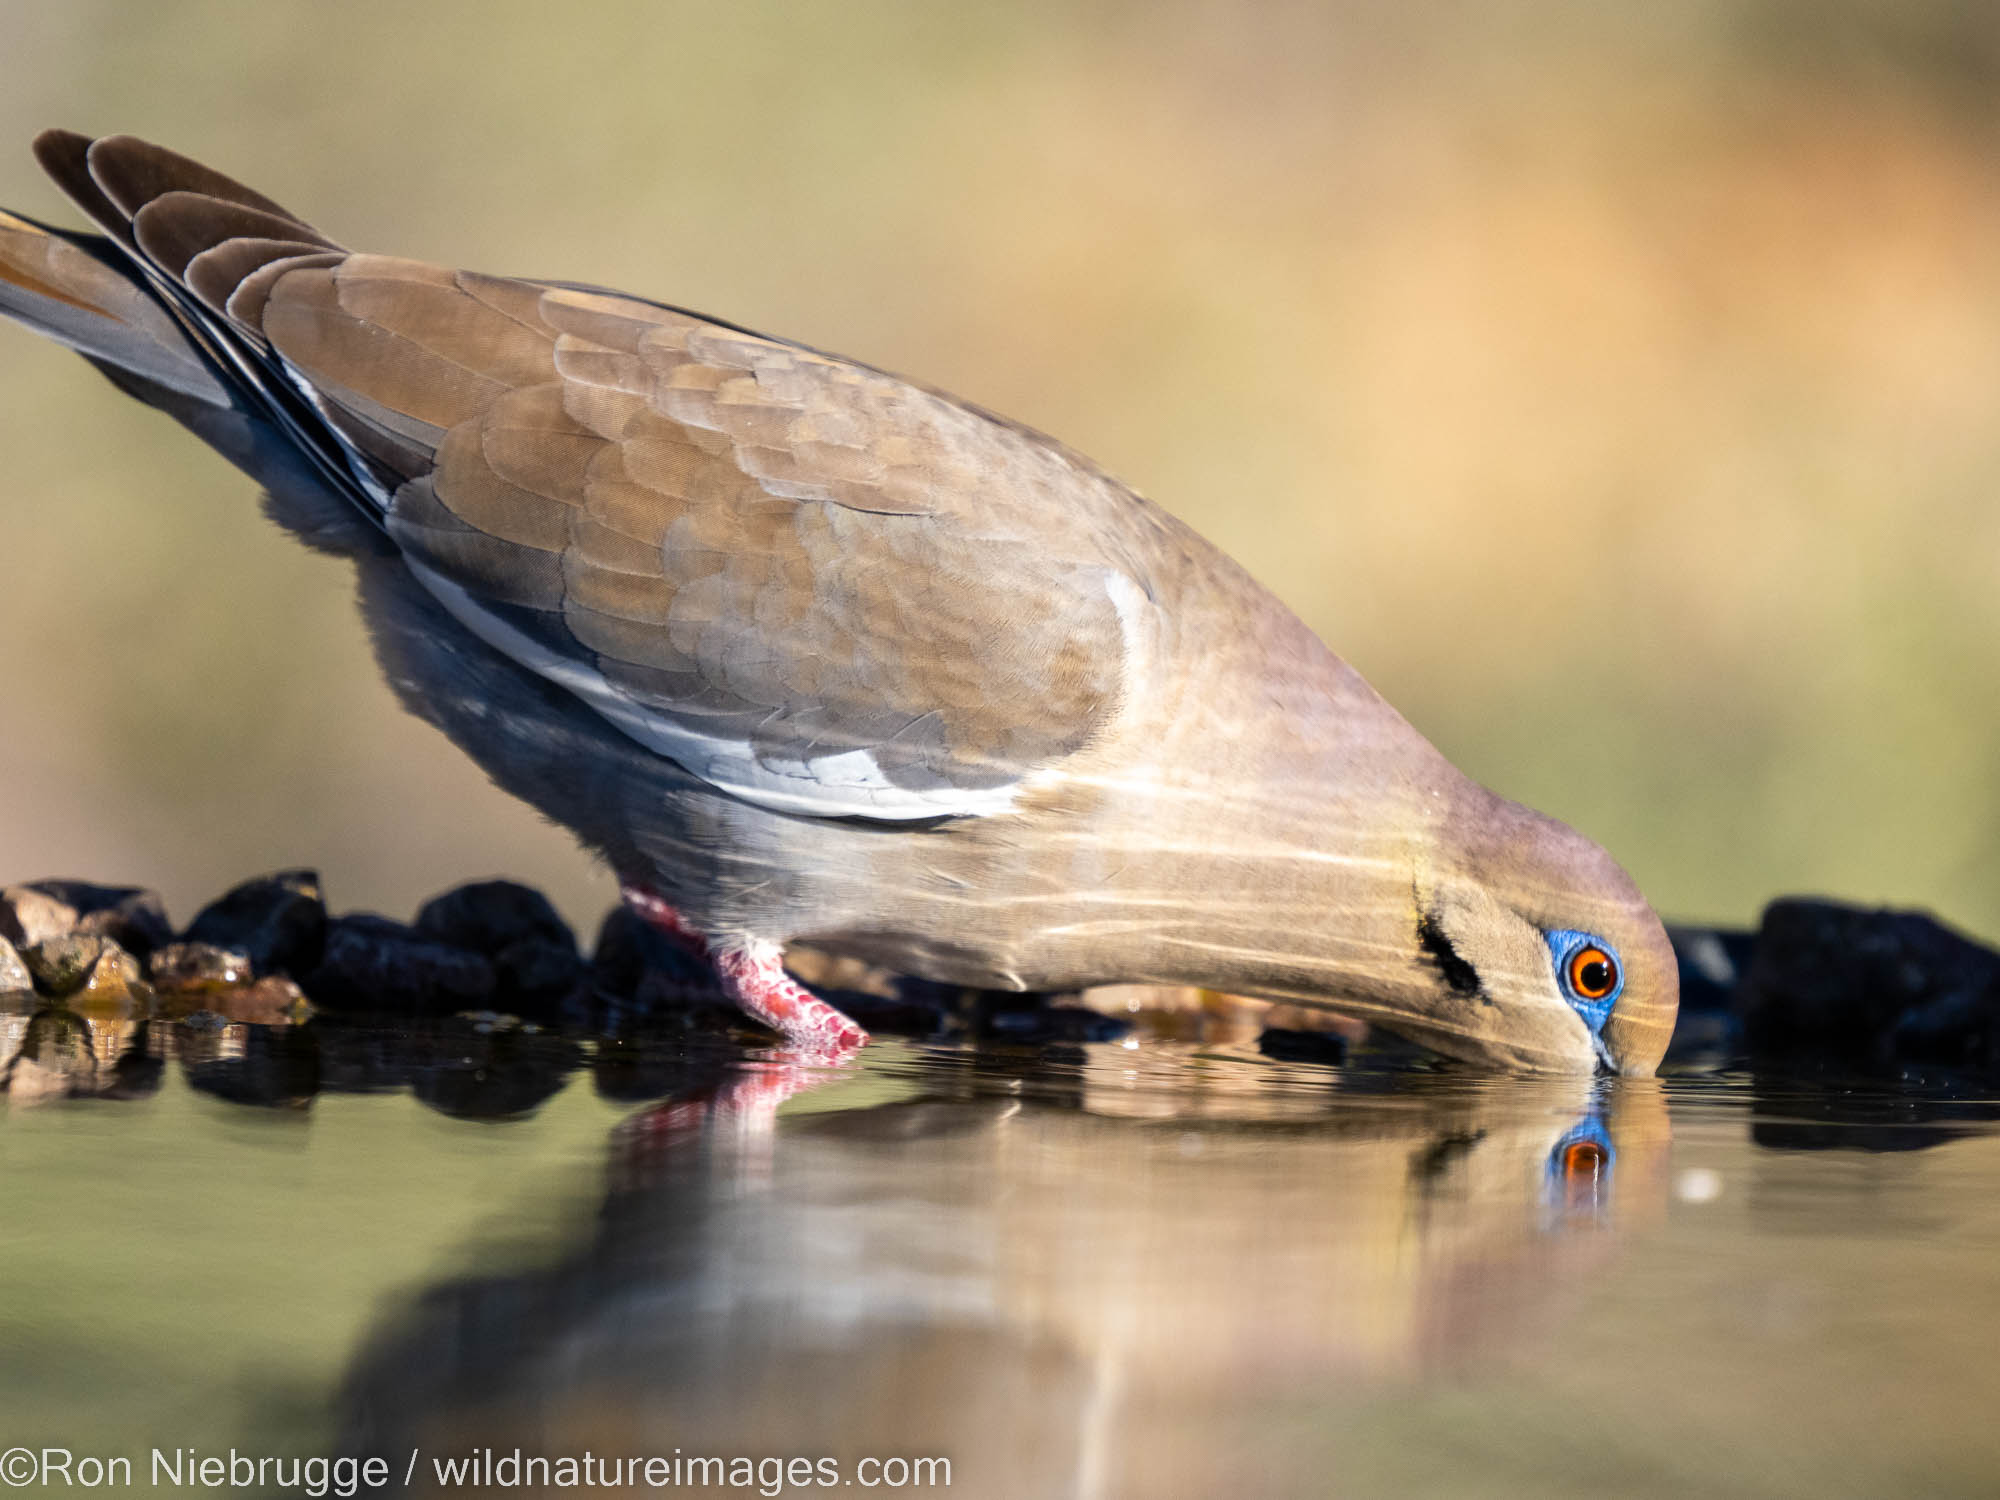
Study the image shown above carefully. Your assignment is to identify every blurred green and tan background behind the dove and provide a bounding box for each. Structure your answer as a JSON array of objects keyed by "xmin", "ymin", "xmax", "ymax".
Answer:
[{"xmin": 0, "ymin": 0, "xmax": 2000, "ymax": 936}]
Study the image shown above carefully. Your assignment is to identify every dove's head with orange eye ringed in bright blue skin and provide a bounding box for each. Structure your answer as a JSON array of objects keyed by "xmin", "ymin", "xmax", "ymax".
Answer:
[{"xmin": 1402, "ymin": 782, "xmax": 1680, "ymax": 1076}]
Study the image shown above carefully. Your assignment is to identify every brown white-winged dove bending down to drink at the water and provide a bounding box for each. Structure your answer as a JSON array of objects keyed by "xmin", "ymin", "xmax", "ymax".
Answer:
[{"xmin": 0, "ymin": 130, "xmax": 1678, "ymax": 1074}]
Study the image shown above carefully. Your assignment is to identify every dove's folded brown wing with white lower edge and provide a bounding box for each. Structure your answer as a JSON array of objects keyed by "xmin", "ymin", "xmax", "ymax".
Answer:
[{"xmin": 27, "ymin": 132, "xmax": 1156, "ymax": 820}]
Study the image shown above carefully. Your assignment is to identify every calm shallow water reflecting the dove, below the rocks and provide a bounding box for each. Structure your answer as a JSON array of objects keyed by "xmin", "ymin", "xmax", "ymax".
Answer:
[{"xmin": 0, "ymin": 1020, "xmax": 2000, "ymax": 1496}]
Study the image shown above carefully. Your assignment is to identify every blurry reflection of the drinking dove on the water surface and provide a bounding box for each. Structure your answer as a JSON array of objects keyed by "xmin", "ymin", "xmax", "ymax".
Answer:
[{"xmin": 342, "ymin": 1052, "xmax": 1668, "ymax": 1500}]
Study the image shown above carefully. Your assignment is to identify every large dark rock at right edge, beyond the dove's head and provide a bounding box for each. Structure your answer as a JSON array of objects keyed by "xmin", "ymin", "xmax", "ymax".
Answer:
[{"xmin": 1736, "ymin": 900, "xmax": 2000, "ymax": 1070}]
